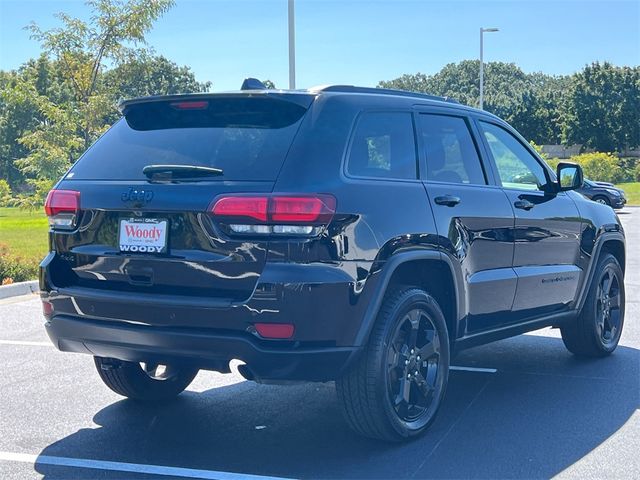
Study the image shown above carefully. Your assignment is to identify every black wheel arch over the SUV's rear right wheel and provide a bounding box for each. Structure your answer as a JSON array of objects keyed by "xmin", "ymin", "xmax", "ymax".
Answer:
[{"xmin": 356, "ymin": 250, "xmax": 464, "ymax": 346}]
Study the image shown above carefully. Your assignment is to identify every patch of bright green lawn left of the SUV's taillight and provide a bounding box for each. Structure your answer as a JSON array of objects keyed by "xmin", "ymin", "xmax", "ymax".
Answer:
[{"xmin": 0, "ymin": 208, "xmax": 49, "ymax": 261}]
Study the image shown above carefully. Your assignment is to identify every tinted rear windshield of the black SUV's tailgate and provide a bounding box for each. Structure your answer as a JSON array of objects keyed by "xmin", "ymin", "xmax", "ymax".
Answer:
[{"xmin": 67, "ymin": 97, "xmax": 306, "ymax": 181}]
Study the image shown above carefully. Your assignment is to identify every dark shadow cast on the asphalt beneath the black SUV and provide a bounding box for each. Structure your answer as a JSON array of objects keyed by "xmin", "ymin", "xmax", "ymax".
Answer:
[{"xmin": 36, "ymin": 335, "xmax": 640, "ymax": 479}]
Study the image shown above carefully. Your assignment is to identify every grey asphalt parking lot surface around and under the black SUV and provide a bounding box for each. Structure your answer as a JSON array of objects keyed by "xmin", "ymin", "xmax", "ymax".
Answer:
[{"xmin": 0, "ymin": 208, "xmax": 640, "ymax": 480}]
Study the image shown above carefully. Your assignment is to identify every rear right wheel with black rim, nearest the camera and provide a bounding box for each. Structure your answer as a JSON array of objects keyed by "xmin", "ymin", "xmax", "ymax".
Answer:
[{"xmin": 336, "ymin": 288, "xmax": 449, "ymax": 442}]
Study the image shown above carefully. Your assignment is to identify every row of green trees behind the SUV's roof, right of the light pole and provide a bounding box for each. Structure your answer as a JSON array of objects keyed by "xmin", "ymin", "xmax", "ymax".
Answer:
[{"xmin": 379, "ymin": 60, "xmax": 640, "ymax": 152}]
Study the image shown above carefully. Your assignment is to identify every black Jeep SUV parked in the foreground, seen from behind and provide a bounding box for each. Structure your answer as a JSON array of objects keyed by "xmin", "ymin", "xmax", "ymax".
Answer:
[{"xmin": 40, "ymin": 86, "xmax": 625, "ymax": 440}]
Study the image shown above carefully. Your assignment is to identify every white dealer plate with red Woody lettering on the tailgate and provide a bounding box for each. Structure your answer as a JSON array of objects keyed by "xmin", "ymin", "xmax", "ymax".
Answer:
[{"xmin": 118, "ymin": 218, "xmax": 169, "ymax": 254}]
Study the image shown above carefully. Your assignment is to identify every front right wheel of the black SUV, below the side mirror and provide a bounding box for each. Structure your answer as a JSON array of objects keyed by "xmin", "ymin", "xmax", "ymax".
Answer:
[{"xmin": 560, "ymin": 253, "xmax": 624, "ymax": 357}]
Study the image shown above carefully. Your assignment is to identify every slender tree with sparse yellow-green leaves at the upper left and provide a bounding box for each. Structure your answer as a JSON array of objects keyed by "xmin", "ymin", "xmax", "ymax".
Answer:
[{"xmin": 10, "ymin": 0, "xmax": 173, "ymax": 206}]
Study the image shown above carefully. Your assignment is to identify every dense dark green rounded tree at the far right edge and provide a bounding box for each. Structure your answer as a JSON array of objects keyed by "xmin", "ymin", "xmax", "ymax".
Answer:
[{"xmin": 562, "ymin": 62, "xmax": 640, "ymax": 152}]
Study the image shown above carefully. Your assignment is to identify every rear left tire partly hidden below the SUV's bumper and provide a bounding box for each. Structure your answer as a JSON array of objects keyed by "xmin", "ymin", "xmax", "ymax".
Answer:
[{"xmin": 93, "ymin": 357, "xmax": 198, "ymax": 402}]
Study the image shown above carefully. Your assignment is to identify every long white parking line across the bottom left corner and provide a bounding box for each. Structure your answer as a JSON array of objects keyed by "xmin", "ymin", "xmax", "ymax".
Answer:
[{"xmin": 0, "ymin": 451, "xmax": 294, "ymax": 480}]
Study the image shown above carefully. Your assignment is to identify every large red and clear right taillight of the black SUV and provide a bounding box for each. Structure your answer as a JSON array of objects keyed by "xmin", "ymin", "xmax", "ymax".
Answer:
[{"xmin": 211, "ymin": 194, "xmax": 336, "ymax": 236}]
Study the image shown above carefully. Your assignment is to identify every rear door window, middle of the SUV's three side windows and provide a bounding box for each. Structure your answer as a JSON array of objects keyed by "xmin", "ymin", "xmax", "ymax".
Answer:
[{"xmin": 419, "ymin": 114, "xmax": 487, "ymax": 185}]
